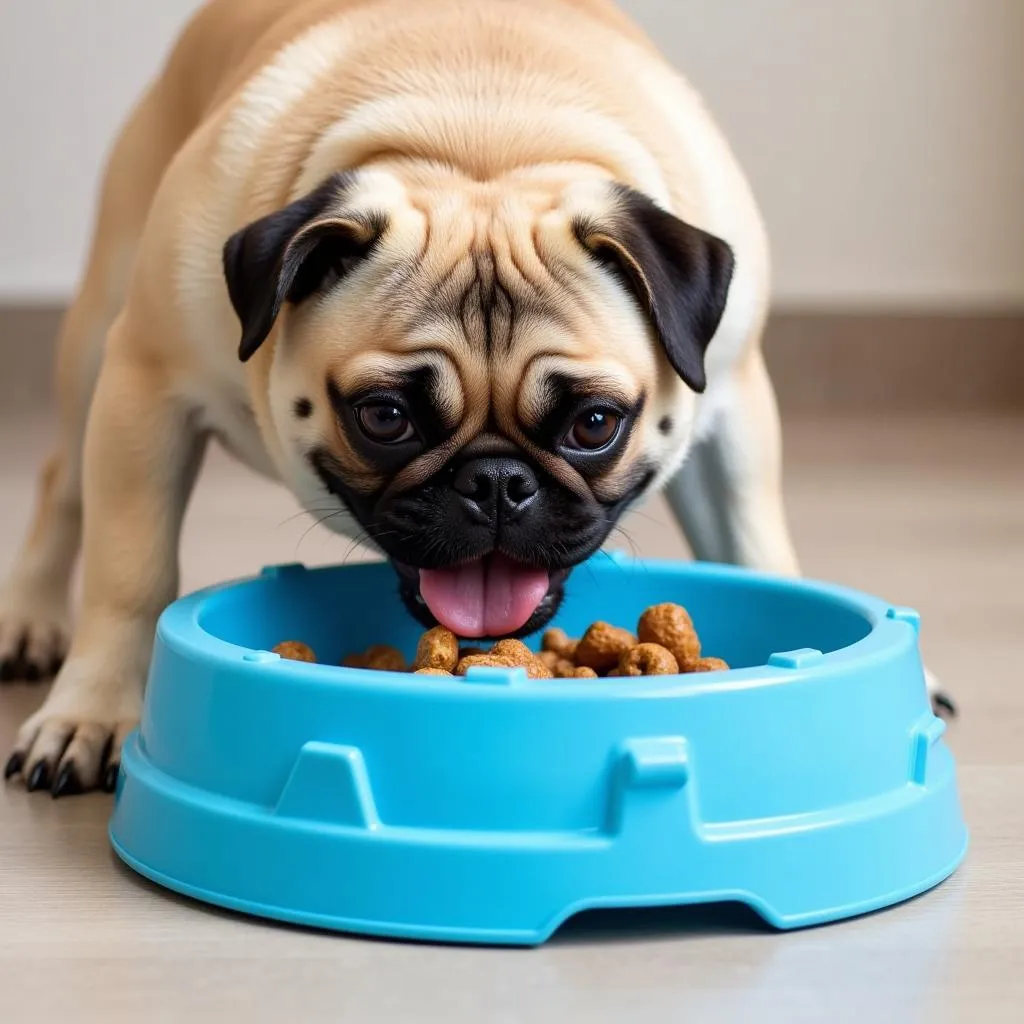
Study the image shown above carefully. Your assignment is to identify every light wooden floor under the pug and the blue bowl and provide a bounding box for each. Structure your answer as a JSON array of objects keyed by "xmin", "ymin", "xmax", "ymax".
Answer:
[{"xmin": 0, "ymin": 411, "xmax": 1024, "ymax": 1024}]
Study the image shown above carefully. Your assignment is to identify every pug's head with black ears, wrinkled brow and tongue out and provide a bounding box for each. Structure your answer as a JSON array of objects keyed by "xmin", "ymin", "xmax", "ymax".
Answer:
[{"xmin": 224, "ymin": 169, "xmax": 732, "ymax": 637}]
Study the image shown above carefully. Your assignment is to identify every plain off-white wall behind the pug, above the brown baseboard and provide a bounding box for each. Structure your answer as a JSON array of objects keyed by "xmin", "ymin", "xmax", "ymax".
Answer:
[{"xmin": 0, "ymin": 0, "xmax": 1024, "ymax": 307}]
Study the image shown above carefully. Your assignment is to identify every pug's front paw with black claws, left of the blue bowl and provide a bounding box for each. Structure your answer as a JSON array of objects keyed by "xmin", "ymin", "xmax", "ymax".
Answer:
[{"xmin": 4, "ymin": 660, "xmax": 141, "ymax": 797}]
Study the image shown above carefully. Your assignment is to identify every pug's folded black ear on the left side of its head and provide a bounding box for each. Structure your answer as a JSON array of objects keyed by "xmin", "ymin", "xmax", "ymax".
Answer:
[{"xmin": 223, "ymin": 174, "xmax": 383, "ymax": 362}]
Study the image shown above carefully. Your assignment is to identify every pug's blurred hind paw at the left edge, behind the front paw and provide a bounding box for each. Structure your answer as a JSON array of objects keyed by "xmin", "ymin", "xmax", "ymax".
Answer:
[{"xmin": 0, "ymin": 590, "xmax": 71, "ymax": 683}]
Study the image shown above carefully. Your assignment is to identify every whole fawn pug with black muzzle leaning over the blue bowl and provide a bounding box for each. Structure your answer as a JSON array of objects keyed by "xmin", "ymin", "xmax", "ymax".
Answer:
[{"xmin": 0, "ymin": 0, "xmax": 798, "ymax": 797}]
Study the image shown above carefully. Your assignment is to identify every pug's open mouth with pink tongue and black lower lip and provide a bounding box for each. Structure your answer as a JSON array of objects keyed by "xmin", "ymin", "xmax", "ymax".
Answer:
[{"xmin": 394, "ymin": 551, "xmax": 569, "ymax": 637}]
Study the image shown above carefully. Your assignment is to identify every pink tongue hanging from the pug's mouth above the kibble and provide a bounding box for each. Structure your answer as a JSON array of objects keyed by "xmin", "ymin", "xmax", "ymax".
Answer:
[{"xmin": 420, "ymin": 554, "xmax": 549, "ymax": 637}]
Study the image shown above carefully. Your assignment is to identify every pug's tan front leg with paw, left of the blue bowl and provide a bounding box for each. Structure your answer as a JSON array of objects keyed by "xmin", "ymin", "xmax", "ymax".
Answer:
[{"xmin": 7, "ymin": 317, "xmax": 204, "ymax": 796}]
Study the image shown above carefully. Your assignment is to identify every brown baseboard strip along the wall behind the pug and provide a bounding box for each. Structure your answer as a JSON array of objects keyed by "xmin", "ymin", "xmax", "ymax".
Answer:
[{"xmin": 0, "ymin": 305, "xmax": 1024, "ymax": 416}]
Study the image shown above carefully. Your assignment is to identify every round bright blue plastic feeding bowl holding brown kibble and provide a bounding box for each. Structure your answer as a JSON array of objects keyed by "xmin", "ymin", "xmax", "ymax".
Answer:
[{"xmin": 111, "ymin": 556, "xmax": 967, "ymax": 944}]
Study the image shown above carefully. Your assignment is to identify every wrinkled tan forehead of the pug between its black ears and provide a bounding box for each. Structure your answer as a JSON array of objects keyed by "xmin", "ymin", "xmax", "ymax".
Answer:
[{"xmin": 303, "ymin": 183, "xmax": 655, "ymax": 422}]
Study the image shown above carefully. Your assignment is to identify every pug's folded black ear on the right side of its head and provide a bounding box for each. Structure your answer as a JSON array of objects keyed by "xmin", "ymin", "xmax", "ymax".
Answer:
[{"xmin": 575, "ymin": 185, "xmax": 734, "ymax": 391}]
